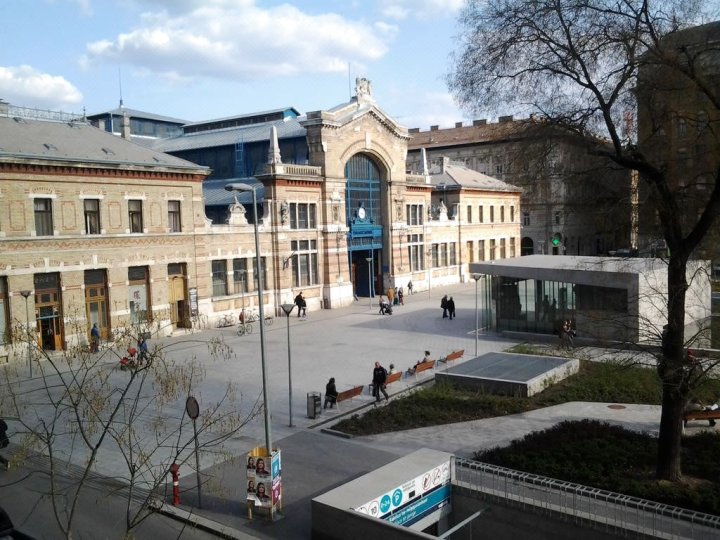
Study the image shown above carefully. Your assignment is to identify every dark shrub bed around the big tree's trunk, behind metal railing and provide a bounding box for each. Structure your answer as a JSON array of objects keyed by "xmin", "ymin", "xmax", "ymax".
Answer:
[{"xmin": 473, "ymin": 420, "xmax": 720, "ymax": 514}]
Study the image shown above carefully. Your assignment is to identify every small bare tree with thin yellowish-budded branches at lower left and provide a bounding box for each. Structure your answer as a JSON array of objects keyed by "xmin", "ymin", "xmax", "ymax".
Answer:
[{"xmin": 0, "ymin": 306, "xmax": 260, "ymax": 538}]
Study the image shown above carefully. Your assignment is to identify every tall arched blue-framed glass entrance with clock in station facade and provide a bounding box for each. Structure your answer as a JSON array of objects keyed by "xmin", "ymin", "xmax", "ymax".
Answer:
[{"xmin": 345, "ymin": 154, "xmax": 383, "ymax": 296}]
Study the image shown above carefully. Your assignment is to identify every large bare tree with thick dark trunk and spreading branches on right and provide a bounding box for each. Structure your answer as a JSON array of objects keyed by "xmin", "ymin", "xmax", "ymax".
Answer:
[{"xmin": 448, "ymin": 0, "xmax": 720, "ymax": 480}]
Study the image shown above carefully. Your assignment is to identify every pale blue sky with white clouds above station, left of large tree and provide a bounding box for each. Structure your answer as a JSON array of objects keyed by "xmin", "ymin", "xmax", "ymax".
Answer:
[{"xmin": 0, "ymin": 0, "xmax": 469, "ymax": 130}]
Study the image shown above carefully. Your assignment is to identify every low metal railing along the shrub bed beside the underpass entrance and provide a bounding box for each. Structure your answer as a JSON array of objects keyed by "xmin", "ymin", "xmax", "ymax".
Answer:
[{"xmin": 452, "ymin": 457, "xmax": 720, "ymax": 539}]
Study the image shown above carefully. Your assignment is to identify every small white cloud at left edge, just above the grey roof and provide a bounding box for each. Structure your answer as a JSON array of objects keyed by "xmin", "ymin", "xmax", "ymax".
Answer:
[{"xmin": 0, "ymin": 65, "xmax": 83, "ymax": 109}]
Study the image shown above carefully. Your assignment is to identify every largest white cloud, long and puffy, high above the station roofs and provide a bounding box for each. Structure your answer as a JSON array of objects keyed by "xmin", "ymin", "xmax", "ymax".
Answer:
[{"xmin": 83, "ymin": 0, "xmax": 395, "ymax": 81}]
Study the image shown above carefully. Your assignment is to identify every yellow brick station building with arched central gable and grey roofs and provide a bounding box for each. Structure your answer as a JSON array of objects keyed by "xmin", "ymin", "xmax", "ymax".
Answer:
[{"xmin": 0, "ymin": 79, "xmax": 520, "ymax": 359}]
